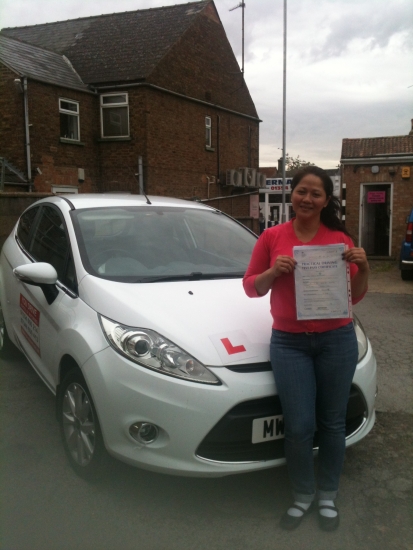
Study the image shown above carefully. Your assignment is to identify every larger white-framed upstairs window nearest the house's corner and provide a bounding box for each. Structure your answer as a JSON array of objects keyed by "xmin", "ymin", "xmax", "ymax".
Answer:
[{"xmin": 100, "ymin": 94, "xmax": 129, "ymax": 138}]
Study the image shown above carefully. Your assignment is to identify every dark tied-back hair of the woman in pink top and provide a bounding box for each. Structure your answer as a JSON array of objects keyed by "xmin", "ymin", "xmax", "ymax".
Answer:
[{"xmin": 291, "ymin": 166, "xmax": 351, "ymax": 237}]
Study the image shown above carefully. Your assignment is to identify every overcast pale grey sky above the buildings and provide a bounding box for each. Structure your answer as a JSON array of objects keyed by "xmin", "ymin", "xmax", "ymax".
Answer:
[{"xmin": 0, "ymin": 0, "xmax": 413, "ymax": 168}]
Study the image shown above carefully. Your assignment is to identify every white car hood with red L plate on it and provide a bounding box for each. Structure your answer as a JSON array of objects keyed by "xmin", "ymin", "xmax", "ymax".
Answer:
[{"xmin": 79, "ymin": 275, "xmax": 272, "ymax": 366}]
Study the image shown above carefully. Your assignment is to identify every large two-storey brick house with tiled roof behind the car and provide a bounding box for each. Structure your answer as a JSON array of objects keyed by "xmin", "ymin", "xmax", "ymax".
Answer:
[{"xmin": 0, "ymin": 0, "xmax": 260, "ymax": 208}]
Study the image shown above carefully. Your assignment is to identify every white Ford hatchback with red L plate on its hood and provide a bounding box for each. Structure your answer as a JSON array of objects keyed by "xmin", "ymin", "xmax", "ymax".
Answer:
[{"xmin": 0, "ymin": 194, "xmax": 376, "ymax": 477}]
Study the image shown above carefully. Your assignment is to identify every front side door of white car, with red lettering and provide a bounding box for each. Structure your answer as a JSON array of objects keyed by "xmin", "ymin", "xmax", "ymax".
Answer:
[{"xmin": 9, "ymin": 205, "xmax": 76, "ymax": 391}]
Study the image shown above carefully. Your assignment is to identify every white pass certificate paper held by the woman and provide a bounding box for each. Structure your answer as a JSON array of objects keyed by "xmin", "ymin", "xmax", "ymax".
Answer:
[{"xmin": 293, "ymin": 244, "xmax": 352, "ymax": 321}]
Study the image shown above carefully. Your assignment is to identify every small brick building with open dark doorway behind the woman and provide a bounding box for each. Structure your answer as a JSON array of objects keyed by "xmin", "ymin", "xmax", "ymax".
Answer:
[{"xmin": 341, "ymin": 120, "xmax": 413, "ymax": 259}]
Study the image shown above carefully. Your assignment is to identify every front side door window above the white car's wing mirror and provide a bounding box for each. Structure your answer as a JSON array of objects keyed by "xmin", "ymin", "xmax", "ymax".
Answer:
[{"xmin": 29, "ymin": 206, "xmax": 76, "ymax": 290}]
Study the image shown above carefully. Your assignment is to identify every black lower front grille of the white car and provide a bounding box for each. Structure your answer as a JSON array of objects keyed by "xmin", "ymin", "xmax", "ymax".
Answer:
[{"xmin": 196, "ymin": 386, "xmax": 367, "ymax": 462}]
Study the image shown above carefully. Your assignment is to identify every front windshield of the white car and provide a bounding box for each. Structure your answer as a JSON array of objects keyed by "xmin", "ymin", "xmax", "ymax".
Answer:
[{"xmin": 72, "ymin": 206, "xmax": 256, "ymax": 283}]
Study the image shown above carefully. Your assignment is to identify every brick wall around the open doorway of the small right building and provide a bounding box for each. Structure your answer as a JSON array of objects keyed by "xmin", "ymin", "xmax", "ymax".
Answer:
[{"xmin": 342, "ymin": 165, "xmax": 413, "ymax": 258}]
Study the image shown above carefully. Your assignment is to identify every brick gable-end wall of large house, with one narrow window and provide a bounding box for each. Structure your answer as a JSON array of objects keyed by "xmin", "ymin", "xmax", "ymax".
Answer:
[{"xmin": 145, "ymin": 90, "xmax": 258, "ymax": 202}]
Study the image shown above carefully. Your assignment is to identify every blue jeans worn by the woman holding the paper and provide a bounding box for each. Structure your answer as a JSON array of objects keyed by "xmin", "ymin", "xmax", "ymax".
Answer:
[{"xmin": 270, "ymin": 323, "xmax": 358, "ymax": 502}]
